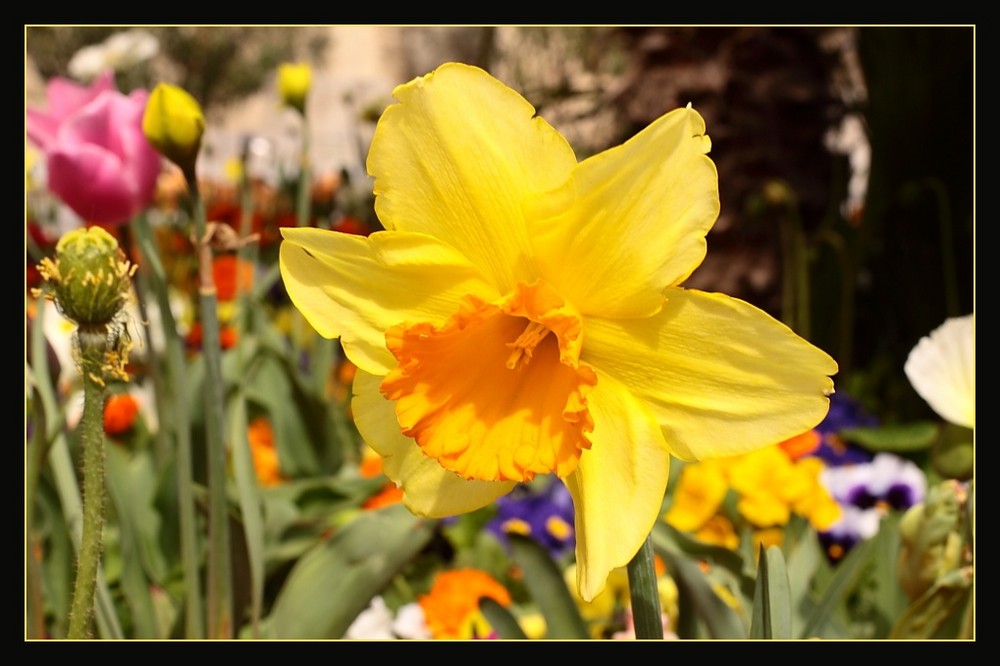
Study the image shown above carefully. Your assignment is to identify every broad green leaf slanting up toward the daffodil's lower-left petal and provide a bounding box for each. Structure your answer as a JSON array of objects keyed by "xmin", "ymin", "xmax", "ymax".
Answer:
[{"xmin": 264, "ymin": 505, "xmax": 434, "ymax": 639}]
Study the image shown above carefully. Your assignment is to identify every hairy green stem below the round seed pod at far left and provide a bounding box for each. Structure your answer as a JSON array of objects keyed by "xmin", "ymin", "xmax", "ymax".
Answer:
[{"xmin": 67, "ymin": 326, "xmax": 108, "ymax": 639}]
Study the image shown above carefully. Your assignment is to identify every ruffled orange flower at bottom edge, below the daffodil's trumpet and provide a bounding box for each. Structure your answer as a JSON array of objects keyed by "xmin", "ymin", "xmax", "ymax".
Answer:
[{"xmin": 417, "ymin": 569, "xmax": 511, "ymax": 639}]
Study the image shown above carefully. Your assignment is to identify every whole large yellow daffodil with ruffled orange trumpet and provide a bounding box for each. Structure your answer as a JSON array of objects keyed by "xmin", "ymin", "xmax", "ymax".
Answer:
[{"xmin": 281, "ymin": 63, "xmax": 837, "ymax": 599}]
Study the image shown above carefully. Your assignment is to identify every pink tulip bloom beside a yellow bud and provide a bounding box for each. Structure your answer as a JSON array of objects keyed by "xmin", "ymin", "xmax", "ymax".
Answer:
[{"xmin": 27, "ymin": 72, "xmax": 161, "ymax": 224}]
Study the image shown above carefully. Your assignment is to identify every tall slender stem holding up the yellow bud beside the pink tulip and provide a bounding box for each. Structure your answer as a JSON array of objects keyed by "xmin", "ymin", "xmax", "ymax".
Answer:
[{"xmin": 188, "ymin": 177, "xmax": 233, "ymax": 639}]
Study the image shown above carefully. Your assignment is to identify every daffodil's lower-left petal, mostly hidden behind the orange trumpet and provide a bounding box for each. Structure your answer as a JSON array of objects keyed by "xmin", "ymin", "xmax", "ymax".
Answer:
[{"xmin": 351, "ymin": 371, "xmax": 517, "ymax": 518}]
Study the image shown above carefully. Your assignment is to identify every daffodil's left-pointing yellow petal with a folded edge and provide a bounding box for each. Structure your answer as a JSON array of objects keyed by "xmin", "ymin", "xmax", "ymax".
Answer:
[{"xmin": 280, "ymin": 228, "xmax": 498, "ymax": 374}]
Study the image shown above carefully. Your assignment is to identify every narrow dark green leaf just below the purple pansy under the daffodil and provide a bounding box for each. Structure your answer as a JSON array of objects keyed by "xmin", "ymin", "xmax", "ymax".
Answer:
[{"xmin": 508, "ymin": 534, "xmax": 590, "ymax": 638}]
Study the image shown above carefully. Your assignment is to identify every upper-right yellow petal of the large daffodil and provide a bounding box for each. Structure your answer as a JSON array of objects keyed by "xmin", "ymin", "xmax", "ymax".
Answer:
[{"xmin": 532, "ymin": 108, "xmax": 719, "ymax": 317}]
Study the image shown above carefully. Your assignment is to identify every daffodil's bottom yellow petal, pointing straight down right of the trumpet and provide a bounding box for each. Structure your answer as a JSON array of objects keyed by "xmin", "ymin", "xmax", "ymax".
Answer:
[{"xmin": 565, "ymin": 375, "xmax": 670, "ymax": 602}]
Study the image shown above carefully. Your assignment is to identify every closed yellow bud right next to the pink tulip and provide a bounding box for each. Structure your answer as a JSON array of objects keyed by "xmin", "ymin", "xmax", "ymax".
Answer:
[{"xmin": 142, "ymin": 83, "xmax": 205, "ymax": 181}]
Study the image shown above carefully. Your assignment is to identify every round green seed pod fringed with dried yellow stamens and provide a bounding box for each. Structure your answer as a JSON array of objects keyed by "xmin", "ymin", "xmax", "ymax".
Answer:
[{"xmin": 38, "ymin": 227, "xmax": 136, "ymax": 328}]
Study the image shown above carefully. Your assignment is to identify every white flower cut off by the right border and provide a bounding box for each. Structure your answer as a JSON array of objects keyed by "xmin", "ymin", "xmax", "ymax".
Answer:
[{"xmin": 903, "ymin": 314, "xmax": 976, "ymax": 428}]
